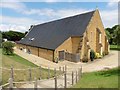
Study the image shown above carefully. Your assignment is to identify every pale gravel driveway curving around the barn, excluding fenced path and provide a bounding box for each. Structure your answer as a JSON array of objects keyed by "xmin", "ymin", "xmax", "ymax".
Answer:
[{"xmin": 15, "ymin": 49, "xmax": 120, "ymax": 72}]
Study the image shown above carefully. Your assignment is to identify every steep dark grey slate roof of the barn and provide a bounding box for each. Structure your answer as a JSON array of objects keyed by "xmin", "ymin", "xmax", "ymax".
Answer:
[{"xmin": 19, "ymin": 11, "xmax": 95, "ymax": 50}]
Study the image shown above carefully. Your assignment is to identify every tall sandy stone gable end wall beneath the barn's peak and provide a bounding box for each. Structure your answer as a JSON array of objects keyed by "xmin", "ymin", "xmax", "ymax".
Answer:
[{"xmin": 87, "ymin": 10, "xmax": 109, "ymax": 53}]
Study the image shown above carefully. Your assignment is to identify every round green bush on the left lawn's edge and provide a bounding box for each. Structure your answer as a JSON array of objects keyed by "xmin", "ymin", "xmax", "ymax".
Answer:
[{"xmin": 2, "ymin": 41, "xmax": 15, "ymax": 55}]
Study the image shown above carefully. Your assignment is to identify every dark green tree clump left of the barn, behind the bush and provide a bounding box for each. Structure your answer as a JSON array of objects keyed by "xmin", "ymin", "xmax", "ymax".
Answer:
[{"xmin": 2, "ymin": 31, "xmax": 25, "ymax": 41}]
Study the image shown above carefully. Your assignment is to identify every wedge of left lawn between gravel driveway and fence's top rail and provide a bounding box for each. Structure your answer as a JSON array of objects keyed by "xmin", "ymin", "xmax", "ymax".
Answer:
[{"xmin": 2, "ymin": 54, "xmax": 38, "ymax": 68}]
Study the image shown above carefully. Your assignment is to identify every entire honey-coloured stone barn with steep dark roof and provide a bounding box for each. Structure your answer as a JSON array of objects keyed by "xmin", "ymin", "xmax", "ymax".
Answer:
[{"xmin": 17, "ymin": 9, "xmax": 109, "ymax": 62}]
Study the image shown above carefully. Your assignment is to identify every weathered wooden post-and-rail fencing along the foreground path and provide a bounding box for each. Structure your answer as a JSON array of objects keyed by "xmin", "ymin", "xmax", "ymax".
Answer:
[{"xmin": 1, "ymin": 66, "xmax": 82, "ymax": 90}]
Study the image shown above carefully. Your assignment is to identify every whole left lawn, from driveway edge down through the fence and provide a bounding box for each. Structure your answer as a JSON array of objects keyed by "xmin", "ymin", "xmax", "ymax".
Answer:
[{"xmin": 0, "ymin": 49, "xmax": 60, "ymax": 84}]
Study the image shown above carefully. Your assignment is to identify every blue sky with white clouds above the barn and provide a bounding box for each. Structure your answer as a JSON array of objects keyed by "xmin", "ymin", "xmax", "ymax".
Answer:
[{"xmin": 0, "ymin": 0, "xmax": 118, "ymax": 32}]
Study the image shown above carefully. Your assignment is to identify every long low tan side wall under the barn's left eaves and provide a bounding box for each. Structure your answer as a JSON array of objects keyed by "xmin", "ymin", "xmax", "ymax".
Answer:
[{"xmin": 16, "ymin": 44, "xmax": 54, "ymax": 61}]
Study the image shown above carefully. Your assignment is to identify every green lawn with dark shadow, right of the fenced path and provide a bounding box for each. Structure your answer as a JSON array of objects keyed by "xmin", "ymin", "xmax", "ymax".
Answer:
[{"xmin": 73, "ymin": 68, "xmax": 120, "ymax": 88}]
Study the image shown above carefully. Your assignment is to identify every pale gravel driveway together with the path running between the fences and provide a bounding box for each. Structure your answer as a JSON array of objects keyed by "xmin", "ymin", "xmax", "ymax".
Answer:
[{"xmin": 15, "ymin": 49, "xmax": 120, "ymax": 88}]
